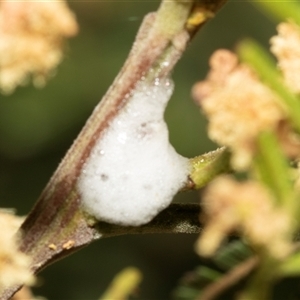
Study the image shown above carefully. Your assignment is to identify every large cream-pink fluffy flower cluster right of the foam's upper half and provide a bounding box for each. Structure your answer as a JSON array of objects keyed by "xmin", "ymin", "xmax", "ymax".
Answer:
[{"xmin": 193, "ymin": 49, "xmax": 285, "ymax": 170}]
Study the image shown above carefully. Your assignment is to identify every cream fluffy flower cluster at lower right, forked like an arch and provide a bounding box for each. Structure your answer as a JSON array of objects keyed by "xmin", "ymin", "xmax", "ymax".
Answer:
[{"xmin": 197, "ymin": 176, "xmax": 292, "ymax": 258}]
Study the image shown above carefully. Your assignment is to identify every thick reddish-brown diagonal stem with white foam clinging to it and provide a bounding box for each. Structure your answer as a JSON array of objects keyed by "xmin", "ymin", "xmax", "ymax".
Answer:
[{"xmin": 0, "ymin": 0, "xmax": 227, "ymax": 300}]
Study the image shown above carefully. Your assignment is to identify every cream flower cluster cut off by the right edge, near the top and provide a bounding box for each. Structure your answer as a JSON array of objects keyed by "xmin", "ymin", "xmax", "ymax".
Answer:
[{"xmin": 270, "ymin": 22, "xmax": 300, "ymax": 93}]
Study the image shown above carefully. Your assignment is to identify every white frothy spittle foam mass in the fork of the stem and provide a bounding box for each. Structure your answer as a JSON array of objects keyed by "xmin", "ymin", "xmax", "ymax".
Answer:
[{"xmin": 78, "ymin": 79, "xmax": 189, "ymax": 226}]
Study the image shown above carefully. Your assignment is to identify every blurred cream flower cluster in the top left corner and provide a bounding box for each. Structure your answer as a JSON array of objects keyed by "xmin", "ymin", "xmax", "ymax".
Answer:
[{"xmin": 0, "ymin": 0, "xmax": 78, "ymax": 93}]
